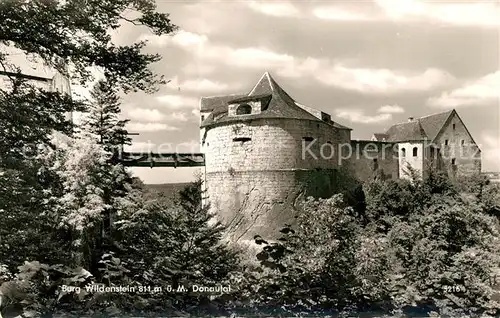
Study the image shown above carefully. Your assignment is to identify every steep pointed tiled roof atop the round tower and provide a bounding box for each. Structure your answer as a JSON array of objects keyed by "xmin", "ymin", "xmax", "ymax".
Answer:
[{"xmin": 201, "ymin": 72, "xmax": 348, "ymax": 129}]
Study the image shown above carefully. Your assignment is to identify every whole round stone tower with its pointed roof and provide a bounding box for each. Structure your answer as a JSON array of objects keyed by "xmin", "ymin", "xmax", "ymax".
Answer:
[{"xmin": 200, "ymin": 72, "xmax": 350, "ymax": 242}]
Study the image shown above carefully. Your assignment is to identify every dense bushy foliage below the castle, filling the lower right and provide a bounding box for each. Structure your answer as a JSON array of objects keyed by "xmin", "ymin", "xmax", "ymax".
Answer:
[{"xmin": 222, "ymin": 173, "xmax": 500, "ymax": 316}]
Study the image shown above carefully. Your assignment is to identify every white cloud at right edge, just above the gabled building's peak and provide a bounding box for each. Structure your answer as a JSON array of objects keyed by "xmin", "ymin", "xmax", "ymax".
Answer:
[{"xmin": 427, "ymin": 71, "xmax": 500, "ymax": 108}]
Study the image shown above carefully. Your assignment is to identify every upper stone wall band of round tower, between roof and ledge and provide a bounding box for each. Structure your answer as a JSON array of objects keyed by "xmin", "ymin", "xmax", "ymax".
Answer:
[{"xmin": 202, "ymin": 119, "xmax": 341, "ymax": 172}]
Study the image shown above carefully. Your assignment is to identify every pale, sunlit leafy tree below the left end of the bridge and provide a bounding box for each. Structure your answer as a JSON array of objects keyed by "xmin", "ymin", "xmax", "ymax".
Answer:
[{"xmin": 40, "ymin": 133, "xmax": 119, "ymax": 272}]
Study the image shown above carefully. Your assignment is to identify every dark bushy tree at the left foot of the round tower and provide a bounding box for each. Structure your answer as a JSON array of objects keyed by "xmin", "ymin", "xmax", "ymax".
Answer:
[{"xmin": 117, "ymin": 181, "xmax": 238, "ymax": 314}]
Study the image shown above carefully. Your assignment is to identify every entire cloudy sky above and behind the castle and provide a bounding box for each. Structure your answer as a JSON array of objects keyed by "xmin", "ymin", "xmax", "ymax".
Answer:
[{"xmin": 107, "ymin": 0, "xmax": 500, "ymax": 183}]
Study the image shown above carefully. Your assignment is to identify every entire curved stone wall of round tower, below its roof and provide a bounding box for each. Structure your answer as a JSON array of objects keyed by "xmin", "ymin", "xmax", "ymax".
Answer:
[{"xmin": 202, "ymin": 119, "xmax": 345, "ymax": 242}]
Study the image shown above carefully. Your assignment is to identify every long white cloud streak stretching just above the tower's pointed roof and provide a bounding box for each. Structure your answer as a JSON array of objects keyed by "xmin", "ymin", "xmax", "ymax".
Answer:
[{"xmin": 144, "ymin": 29, "xmax": 453, "ymax": 94}]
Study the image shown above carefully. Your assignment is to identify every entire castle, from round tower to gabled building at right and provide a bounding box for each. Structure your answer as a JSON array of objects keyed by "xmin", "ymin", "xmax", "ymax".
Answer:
[{"xmin": 200, "ymin": 72, "xmax": 481, "ymax": 241}]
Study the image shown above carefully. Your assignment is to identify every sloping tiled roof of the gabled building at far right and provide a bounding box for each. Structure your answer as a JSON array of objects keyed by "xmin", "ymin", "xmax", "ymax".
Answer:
[{"xmin": 382, "ymin": 110, "xmax": 453, "ymax": 142}]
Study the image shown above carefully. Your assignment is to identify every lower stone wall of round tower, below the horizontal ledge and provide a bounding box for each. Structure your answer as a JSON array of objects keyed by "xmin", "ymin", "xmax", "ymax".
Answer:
[{"xmin": 206, "ymin": 169, "xmax": 337, "ymax": 242}]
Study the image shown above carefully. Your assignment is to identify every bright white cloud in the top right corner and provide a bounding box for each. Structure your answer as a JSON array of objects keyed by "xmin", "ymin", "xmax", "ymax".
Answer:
[{"xmin": 375, "ymin": 0, "xmax": 500, "ymax": 27}]
